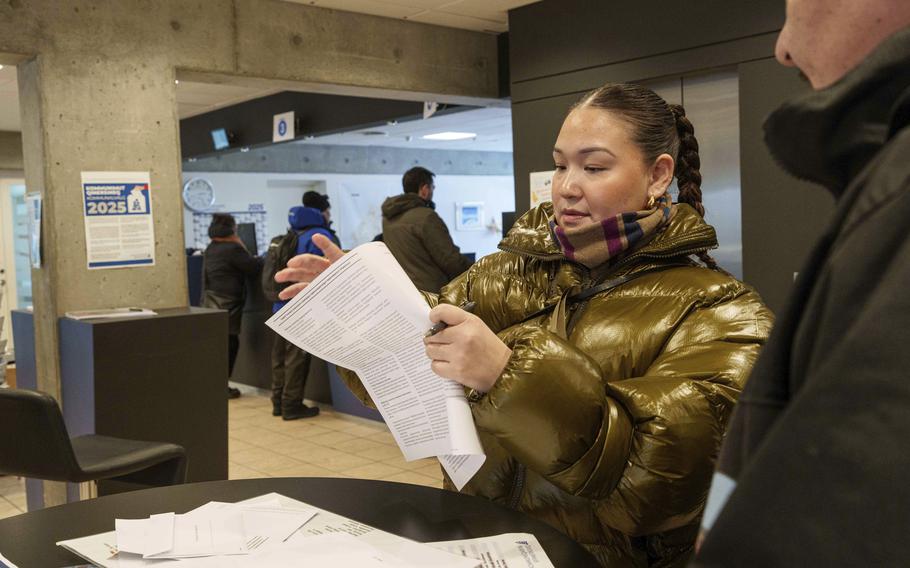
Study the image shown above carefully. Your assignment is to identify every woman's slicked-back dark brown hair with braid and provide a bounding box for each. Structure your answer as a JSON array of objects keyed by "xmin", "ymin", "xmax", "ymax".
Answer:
[{"xmin": 570, "ymin": 83, "xmax": 718, "ymax": 269}]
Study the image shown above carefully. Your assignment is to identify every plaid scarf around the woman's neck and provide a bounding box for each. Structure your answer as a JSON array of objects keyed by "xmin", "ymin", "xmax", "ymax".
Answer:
[{"xmin": 550, "ymin": 193, "xmax": 676, "ymax": 268}]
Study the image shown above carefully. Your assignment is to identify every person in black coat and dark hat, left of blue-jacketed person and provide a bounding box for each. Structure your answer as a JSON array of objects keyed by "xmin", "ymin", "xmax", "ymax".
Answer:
[{"xmin": 202, "ymin": 213, "xmax": 262, "ymax": 398}]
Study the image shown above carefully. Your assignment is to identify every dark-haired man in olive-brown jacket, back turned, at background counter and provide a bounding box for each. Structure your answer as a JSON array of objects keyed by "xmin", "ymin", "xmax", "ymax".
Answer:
[{"xmin": 382, "ymin": 167, "xmax": 471, "ymax": 293}]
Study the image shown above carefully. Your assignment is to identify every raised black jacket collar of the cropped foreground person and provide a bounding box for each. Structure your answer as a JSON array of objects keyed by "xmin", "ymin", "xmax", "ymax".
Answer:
[{"xmin": 765, "ymin": 28, "xmax": 910, "ymax": 196}]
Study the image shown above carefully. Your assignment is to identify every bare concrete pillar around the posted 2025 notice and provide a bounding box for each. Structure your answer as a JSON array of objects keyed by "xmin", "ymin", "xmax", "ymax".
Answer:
[{"xmin": 19, "ymin": 53, "xmax": 188, "ymax": 505}]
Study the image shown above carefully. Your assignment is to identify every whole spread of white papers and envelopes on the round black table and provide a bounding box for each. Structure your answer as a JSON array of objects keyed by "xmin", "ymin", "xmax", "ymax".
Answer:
[{"xmin": 57, "ymin": 493, "xmax": 553, "ymax": 568}]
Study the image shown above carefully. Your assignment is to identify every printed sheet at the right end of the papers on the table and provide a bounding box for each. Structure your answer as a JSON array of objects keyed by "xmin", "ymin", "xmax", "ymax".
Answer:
[{"xmin": 427, "ymin": 533, "xmax": 555, "ymax": 568}]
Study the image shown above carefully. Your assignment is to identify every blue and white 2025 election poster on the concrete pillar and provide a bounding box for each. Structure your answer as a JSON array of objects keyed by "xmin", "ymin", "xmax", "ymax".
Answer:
[{"xmin": 82, "ymin": 172, "xmax": 155, "ymax": 270}]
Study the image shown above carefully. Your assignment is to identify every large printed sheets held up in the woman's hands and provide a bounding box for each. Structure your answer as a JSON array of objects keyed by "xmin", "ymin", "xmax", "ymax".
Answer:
[{"xmin": 266, "ymin": 242, "xmax": 486, "ymax": 489}]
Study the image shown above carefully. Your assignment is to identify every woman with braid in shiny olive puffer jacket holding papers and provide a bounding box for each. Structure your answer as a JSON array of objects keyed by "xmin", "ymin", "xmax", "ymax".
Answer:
[{"xmin": 274, "ymin": 85, "xmax": 772, "ymax": 567}]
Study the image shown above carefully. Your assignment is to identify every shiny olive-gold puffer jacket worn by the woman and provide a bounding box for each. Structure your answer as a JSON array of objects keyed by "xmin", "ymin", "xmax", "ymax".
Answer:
[{"xmin": 345, "ymin": 203, "xmax": 772, "ymax": 566}]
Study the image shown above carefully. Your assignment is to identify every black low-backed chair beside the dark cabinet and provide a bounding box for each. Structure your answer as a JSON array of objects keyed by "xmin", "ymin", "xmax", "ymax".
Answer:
[{"xmin": 0, "ymin": 389, "xmax": 186, "ymax": 487}]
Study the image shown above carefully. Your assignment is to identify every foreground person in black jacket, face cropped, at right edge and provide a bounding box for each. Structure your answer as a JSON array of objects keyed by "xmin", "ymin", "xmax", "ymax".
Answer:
[{"xmin": 695, "ymin": 0, "xmax": 910, "ymax": 567}]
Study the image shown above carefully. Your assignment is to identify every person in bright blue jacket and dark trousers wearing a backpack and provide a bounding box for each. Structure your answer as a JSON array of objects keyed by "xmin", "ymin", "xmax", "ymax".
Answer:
[{"xmin": 272, "ymin": 205, "xmax": 336, "ymax": 420}]
